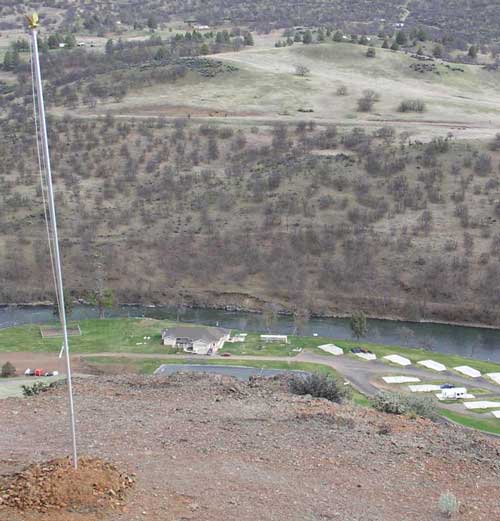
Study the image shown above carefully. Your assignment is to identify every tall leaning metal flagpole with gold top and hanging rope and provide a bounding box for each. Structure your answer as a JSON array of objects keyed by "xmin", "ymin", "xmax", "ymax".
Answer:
[{"xmin": 27, "ymin": 13, "xmax": 78, "ymax": 469}]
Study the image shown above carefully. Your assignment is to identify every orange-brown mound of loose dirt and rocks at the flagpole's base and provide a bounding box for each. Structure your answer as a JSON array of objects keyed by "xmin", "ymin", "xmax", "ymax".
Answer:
[{"xmin": 0, "ymin": 457, "xmax": 134, "ymax": 512}]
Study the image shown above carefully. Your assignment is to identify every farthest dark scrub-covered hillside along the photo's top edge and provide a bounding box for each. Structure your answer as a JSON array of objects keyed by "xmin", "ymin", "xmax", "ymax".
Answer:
[{"xmin": 0, "ymin": 0, "xmax": 500, "ymax": 49}]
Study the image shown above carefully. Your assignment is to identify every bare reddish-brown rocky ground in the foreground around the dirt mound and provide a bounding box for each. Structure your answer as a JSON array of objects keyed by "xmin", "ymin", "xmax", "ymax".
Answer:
[{"xmin": 0, "ymin": 375, "xmax": 500, "ymax": 521}]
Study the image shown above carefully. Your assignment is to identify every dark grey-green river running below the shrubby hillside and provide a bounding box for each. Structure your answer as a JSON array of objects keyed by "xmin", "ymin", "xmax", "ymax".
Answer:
[{"xmin": 0, "ymin": 305, "xmax": 500, "ymax": 362}]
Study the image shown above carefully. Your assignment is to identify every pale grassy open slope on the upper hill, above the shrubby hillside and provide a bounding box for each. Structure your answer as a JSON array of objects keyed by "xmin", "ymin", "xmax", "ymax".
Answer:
[{"xmin": 91, "ymin": 39, "xmax": 500, "ymax": 140}]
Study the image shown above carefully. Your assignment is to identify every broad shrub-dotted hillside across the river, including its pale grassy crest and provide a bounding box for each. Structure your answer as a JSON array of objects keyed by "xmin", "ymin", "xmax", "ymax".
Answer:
[{"xmin": 0, "ymin": 16, "xmax": 500, "ymax": 325}]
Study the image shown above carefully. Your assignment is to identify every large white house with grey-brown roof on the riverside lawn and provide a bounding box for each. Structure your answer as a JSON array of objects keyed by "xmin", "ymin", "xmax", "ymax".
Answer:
[{"xmin": 161, "ymin": 326, "xmax": 230, "ymax": 355}]
